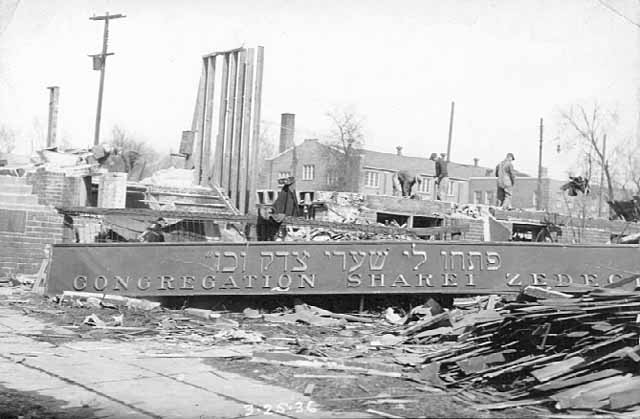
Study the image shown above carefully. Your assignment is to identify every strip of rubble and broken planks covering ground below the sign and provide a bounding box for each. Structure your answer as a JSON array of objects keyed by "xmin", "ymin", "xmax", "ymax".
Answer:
[{"xmin": 0, "ymin": 285, "xmax": 640, "ymax": 418}]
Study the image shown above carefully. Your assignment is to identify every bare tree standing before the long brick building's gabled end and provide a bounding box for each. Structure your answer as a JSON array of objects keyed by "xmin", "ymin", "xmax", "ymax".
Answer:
[{"xmin": 326, "ymin": 108, "xmax": 364, "ymax": 191}]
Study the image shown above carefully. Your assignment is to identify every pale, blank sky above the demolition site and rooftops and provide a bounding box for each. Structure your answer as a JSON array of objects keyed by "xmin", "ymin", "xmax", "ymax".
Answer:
[{"xmin": 0, "ymin": 0, "xmax": 640, "ymax": 177}]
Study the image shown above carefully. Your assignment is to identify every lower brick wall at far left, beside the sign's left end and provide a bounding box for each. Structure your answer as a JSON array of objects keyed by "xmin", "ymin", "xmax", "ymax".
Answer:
[{"xmin": 0, "ymin": 208, "xmax": 63, "ymax": 276}]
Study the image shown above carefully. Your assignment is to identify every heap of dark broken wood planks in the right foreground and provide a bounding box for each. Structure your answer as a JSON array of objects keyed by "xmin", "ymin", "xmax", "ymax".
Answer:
[{"xmin": 410, "ymin": 287, "xmax": 640, "ymax": 417}]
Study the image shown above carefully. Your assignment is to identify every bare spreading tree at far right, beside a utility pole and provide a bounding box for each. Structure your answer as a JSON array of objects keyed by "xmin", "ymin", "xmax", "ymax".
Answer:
[{"xmin": 560, "ymin": 103, "xmax": 617, "ymax": 206}]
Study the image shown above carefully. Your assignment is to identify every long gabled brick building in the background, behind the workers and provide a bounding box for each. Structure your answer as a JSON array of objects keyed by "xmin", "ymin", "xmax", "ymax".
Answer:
[{"xmin": 258, "ymin": 139, "xmax": 490, "ymax": 203}]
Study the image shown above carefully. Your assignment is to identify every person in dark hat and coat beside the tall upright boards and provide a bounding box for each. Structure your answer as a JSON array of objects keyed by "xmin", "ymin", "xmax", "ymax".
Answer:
[{"xmin": 256, "ymin": 176, "xmax": 301, "ymax": 241}]
